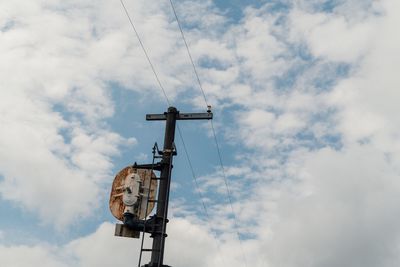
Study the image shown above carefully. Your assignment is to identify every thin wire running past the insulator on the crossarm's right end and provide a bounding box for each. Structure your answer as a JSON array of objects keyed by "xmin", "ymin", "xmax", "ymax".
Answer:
[{"xmin": 169, "ymin": 0, "xmax": 247, "ymax": 266}]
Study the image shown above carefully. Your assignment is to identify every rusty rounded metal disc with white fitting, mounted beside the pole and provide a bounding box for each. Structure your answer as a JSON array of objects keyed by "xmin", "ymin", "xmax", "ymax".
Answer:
[{"xmin": 109, "ymin": 166, "xmax": 158, "ymax": 221}]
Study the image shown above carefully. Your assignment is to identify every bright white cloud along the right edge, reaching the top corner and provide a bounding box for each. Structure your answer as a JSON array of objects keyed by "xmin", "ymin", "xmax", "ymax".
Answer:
[{"xmin": 332, "ymin": 1, "xmax": 400, "ymax": 148}]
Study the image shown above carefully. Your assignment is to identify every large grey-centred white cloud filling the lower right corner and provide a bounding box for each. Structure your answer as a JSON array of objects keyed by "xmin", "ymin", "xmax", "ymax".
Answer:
[{"xmin": 263, "ymin": 146, "xmax": 400, "ymax": 266}]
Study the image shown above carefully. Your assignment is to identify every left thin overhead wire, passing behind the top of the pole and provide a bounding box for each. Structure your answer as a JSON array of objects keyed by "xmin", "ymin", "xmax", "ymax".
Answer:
[{"xmin": 120, "ymin": 0, "xmax": 225, "ymax": 266}]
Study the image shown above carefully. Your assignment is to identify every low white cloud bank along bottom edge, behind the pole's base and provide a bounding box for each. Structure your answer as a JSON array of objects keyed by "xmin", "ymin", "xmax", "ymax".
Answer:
[{"xmin": 0, "ymin": 222, "xmax": 223, "ymax": 267}]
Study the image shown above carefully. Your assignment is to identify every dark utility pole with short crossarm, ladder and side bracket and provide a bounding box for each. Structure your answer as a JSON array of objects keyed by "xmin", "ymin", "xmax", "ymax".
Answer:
[{"xmin": 111, "ymin": 107, "xmax": 213, "ymax": 267}]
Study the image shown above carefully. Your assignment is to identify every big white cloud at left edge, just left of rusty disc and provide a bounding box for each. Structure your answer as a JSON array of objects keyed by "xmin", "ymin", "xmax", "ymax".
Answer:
[{"xmin": 0, "ymin": 86, "xmax": 130, "ymax": 228}]
